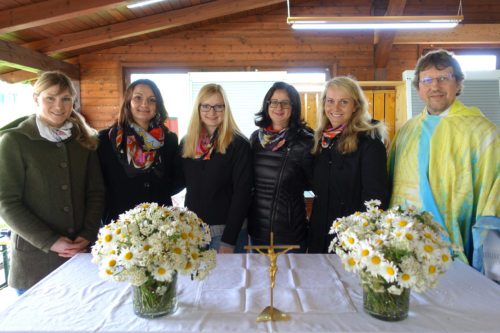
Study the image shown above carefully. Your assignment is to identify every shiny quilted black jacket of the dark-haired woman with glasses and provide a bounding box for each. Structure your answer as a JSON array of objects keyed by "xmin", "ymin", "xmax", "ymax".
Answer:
[{"xmin": 248, "ymin": 129, "xmax": 314, "ymax": 244}]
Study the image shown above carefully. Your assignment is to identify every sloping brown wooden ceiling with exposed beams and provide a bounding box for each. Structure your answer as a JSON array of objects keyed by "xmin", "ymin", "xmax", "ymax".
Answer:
[{"xmin": 0, "ymin": 0, "xmax": 500, "ymax": 82}]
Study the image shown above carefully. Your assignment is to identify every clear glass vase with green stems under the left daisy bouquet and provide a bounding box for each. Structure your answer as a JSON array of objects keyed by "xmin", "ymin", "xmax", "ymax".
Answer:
[{"xmin": 133, "ymin": 272, "xmax": 177, "ymax": 318}]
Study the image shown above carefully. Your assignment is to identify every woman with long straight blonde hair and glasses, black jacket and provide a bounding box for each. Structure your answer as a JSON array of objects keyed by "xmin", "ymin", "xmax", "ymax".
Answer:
[{"xmin": 181, "ymin": 84, "xmax": 252, "ymax": 253}]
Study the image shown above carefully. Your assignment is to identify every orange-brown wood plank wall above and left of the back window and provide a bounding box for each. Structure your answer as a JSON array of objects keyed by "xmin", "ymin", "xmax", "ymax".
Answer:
[{"xmin": 79, "ymin": 2, "xmax": 419, "ymax": 129}]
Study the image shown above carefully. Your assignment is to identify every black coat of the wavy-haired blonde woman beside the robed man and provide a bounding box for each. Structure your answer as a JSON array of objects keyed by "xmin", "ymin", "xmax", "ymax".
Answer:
[{"xmin": 309, "ymin": 135, "xmax": 389, "ymax": 253}]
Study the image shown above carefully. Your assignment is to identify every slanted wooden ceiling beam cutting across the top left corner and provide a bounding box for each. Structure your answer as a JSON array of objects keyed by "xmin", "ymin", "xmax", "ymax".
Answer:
[{"xmin": 0, "ymin": 0, "xmax": 128, "ymax": 34}]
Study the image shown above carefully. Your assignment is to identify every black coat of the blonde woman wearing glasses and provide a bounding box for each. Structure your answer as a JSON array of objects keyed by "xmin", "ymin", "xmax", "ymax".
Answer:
[{"xmin": 180, "ymin": 135, "xmax": 252, "ymax": 245}]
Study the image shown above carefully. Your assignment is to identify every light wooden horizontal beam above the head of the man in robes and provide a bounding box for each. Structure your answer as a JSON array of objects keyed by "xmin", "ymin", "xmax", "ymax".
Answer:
[{"xmin": 394, "ymin": 24, "xmax": 500, "ymax": 45}]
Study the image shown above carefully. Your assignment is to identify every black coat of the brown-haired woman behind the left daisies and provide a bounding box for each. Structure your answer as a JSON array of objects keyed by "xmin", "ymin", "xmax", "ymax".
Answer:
[{"xmin": 97, "ymin": 128, "xmax": 180, "ymax": 224}]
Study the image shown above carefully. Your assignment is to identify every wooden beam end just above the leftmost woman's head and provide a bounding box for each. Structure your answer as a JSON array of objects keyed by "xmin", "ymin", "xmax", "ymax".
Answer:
[{"xmin": 0, "ymin": 41, "xmax": 80, "ymax": 80}]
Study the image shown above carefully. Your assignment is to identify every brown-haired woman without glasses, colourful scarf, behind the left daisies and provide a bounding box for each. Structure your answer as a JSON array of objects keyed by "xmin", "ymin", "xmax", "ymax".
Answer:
[{"xmin": 97, "ymin": 79, "xmax": 180, "ymax": 224}]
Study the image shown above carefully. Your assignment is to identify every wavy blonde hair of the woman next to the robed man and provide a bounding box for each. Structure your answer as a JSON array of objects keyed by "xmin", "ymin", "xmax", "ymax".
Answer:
[{"xmin": 312, "ymin": 76, "xmax": 387, "ymax": 154}]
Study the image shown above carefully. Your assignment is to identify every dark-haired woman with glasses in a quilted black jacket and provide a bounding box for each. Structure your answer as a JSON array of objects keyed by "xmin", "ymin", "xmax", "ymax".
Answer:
[{"xmin": 248, "ymin": 82, "xmax": 313, "ymax": 252}]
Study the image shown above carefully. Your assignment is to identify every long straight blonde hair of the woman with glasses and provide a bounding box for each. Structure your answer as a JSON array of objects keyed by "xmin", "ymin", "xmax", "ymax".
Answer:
[{"xmin": 182, "ymin": 83, "xmax": 241, "ymax": 158}]
